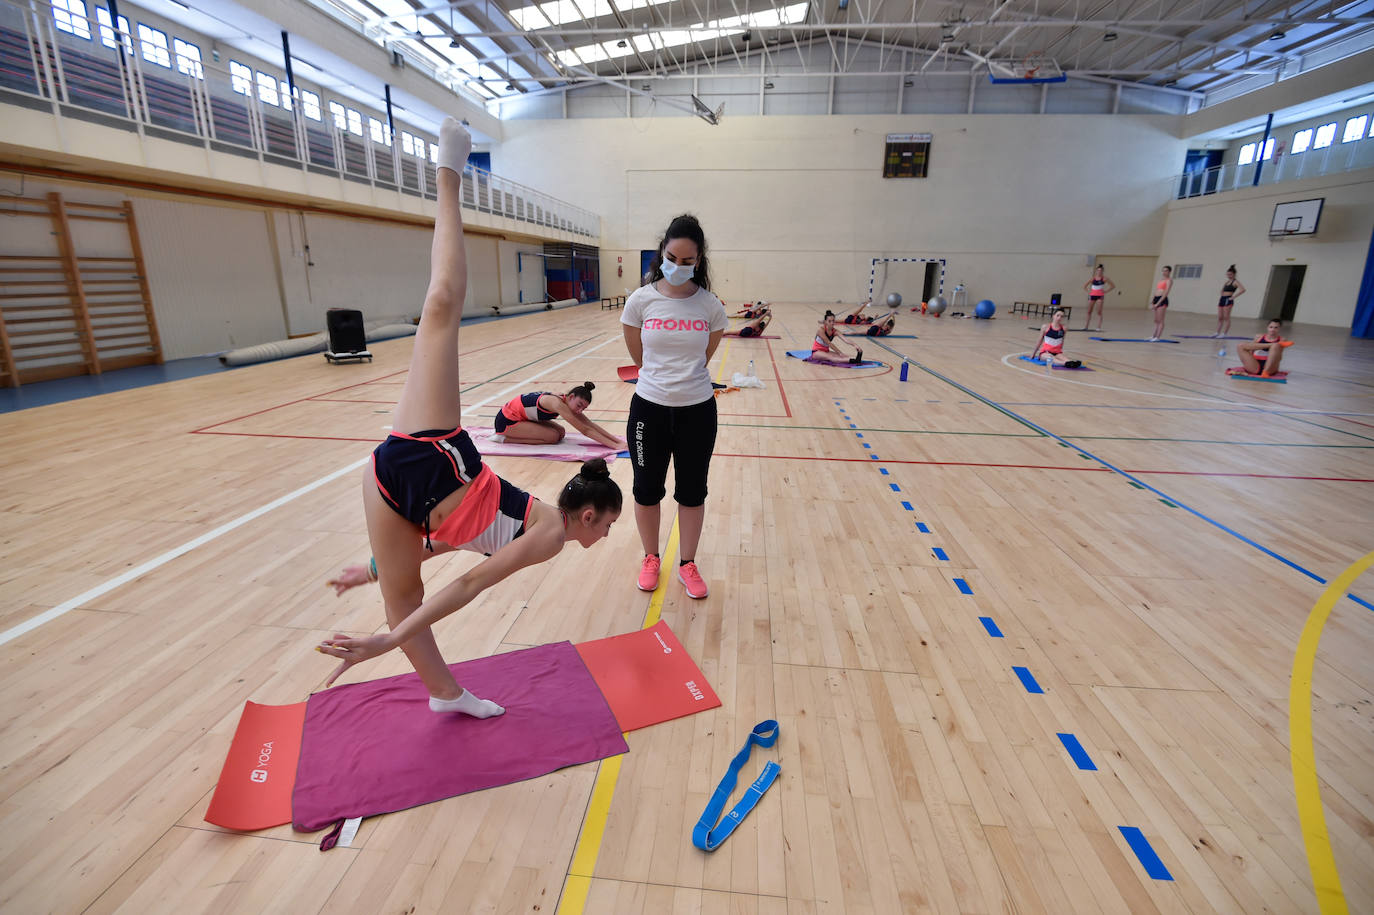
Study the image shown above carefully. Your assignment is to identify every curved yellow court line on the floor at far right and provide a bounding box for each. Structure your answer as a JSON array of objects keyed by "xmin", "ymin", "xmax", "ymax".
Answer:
[{"xmin": 1289, "ymin": 552, "xmax": 1374, "ymax": 915}]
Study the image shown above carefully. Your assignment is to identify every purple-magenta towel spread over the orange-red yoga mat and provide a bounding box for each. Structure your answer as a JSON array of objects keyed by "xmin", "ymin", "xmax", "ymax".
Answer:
[{"xmin": 291, "ymin": 642, "xmax": 629, "ymax": 833}]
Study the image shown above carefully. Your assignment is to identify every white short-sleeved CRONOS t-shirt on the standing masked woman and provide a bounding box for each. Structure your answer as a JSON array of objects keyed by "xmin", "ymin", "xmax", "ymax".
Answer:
[{"xmin": 620, "ymin": 284, "xmax": 730, "ymax": 407}]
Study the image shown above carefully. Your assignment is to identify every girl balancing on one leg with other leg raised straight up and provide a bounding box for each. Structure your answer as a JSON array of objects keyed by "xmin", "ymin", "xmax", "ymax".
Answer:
[{"xmin": 316, "ymin": 118, "xmax": 621, "ymax": 719}]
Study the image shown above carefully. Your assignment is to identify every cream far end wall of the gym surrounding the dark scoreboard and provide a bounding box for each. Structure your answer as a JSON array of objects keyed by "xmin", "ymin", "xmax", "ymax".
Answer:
[{"xmin": 493, "ymin": 109, "xmax": 1184, "ymax": 304}]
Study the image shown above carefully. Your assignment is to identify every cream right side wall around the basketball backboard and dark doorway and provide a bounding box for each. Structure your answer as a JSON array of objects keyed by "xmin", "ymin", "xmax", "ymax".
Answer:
[{"xmin": 1160, "ymin": 169, "xmax": 1374, "ymax": 327}]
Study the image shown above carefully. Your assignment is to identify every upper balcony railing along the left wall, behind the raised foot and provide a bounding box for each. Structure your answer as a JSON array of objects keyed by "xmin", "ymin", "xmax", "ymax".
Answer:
[{"xmin": 0, "ymin": 0, "xmax": 600, "ymax": 239}]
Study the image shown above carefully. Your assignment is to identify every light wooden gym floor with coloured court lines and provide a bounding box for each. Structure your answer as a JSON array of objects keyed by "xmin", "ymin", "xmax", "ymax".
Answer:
[{"xmin": 0, "ymin": 304, "xmax": 1374, "ymax": 915}]
